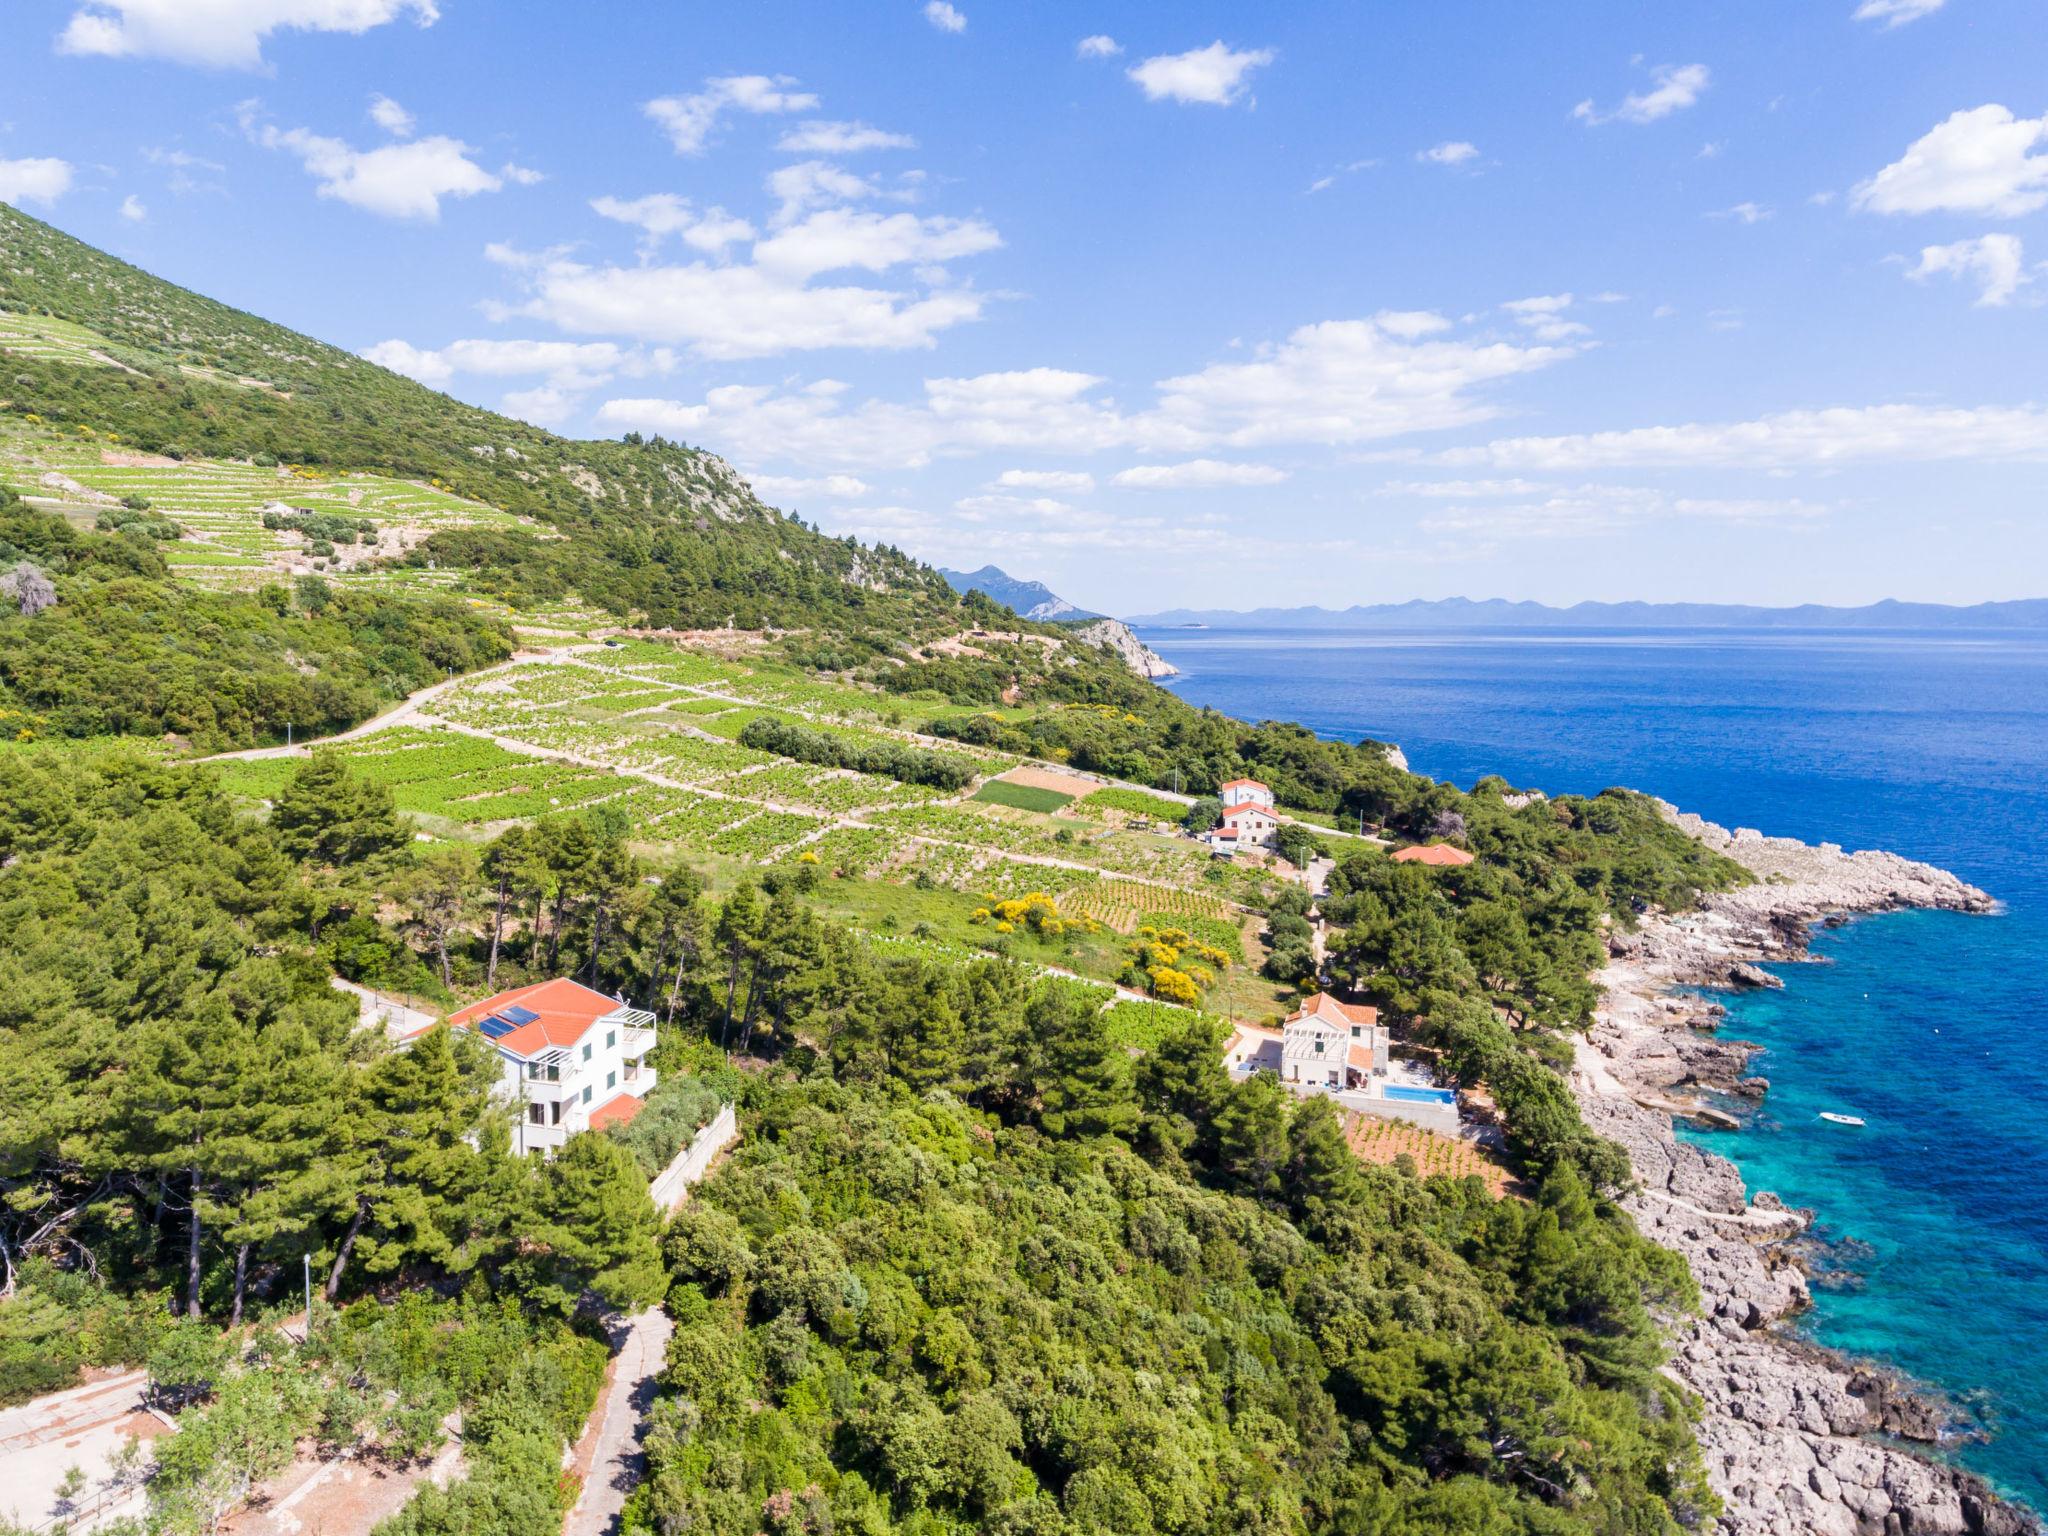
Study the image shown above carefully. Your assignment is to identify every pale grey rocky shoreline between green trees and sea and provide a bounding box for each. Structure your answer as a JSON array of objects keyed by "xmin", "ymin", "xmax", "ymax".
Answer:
[{"xmin": 1573, "ymin": 805, "xmax": 2040, "ymax": 1536}]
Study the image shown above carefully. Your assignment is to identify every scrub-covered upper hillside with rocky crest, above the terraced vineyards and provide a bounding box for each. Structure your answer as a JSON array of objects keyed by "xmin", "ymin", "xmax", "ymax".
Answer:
[{"xmin": 0, "ymin": 205, "xmax": 956, "ymax": 637}]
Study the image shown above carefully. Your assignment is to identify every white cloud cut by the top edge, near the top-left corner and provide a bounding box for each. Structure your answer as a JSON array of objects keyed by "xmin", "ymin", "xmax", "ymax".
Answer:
[{"xmin": 57, "ymin": 0, "xmax": 440, "ymax": 70}]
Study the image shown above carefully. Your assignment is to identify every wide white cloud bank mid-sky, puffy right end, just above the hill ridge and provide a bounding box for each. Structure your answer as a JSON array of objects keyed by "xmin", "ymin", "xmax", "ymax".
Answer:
[{"xmin": 598, "ymin": 307, "xmax": 1575, "ymax": 467}]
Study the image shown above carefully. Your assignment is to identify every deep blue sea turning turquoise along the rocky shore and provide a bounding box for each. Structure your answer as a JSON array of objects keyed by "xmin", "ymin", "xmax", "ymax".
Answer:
[{"xmin": 1141, "ymin": 629, "xmax": 2048, "ymax": 1509}]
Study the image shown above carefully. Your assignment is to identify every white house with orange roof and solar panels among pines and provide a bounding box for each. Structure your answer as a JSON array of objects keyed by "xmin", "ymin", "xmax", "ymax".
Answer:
[{"xmin": 436, "ymin": 977, "xmax": 655, "ymax": 1153}]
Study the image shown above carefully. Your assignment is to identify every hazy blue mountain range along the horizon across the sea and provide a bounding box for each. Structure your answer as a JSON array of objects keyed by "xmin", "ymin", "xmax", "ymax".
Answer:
[{"xmin": 1122, "ymin": 593, "xmax": 2048, "ymax": 629}]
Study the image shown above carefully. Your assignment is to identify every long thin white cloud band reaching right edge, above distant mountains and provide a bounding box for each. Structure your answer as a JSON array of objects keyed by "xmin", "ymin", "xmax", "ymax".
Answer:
[{"xmin": 1438, "ymin": 406, "xmax": 2048, "ymax": 471}]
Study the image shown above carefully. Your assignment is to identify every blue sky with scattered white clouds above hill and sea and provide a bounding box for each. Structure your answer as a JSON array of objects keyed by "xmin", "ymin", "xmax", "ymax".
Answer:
[{"xmin": 0, "ymin": 0, "xmax": 2048, "ymax": 612}]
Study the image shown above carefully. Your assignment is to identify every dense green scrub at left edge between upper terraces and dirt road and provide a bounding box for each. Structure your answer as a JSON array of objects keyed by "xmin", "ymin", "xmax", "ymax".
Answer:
[{"xmin": 0, "ymin": 487, "xmax": 512, "ymax": 748}]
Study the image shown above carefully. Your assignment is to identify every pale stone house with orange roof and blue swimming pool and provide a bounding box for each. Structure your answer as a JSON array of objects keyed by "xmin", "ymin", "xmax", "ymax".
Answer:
[{"xmin": 1223, "ymin": 991, "xmax": 1458, "ymax": 1135}]
